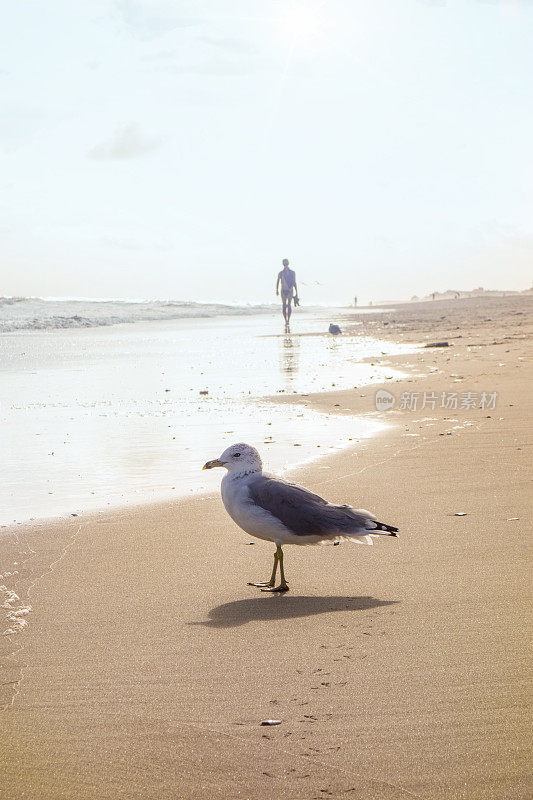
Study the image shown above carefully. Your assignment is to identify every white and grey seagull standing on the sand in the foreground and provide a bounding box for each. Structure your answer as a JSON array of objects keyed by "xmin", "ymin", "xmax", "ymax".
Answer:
[{"xmin": 203, "ymin": 443, "xmax": 398, "ymax": 592}]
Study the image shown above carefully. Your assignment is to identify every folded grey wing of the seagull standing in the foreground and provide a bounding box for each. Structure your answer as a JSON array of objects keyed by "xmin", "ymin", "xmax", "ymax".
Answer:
[{"xmin": 248, "ymin": 475, "xmax": 390, "ymax": 537}]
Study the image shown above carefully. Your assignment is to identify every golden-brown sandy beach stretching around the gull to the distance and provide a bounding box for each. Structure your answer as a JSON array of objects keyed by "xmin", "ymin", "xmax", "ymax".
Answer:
[{"xmin": 0, "ymin": 296, "xmax": 533, "ymax": 800}]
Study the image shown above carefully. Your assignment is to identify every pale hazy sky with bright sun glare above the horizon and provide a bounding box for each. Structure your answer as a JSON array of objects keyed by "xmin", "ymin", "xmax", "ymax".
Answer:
[{"xmin": 0, "ymin": 0, "xmax": 533, "ymax": 303}]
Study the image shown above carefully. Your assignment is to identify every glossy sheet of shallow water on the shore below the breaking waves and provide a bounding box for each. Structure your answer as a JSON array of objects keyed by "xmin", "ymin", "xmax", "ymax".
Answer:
[{"xmin": 0, "ymin": 307, "xmax": 412, "ymax": 525}]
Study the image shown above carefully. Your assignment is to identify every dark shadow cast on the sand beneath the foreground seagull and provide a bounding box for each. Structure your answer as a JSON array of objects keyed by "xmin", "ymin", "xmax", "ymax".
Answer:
[{"xmin": 188, "ymin": 594, "xmax": 398, "ymax": 628}]
